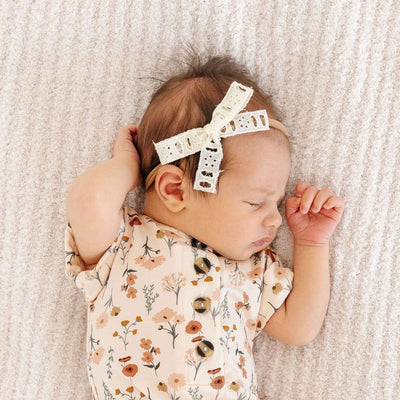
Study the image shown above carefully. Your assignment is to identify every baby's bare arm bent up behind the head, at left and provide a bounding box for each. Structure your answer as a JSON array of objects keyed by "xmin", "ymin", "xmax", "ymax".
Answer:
[{"xmin": 67, "ymin": 125, "xmax": 141, "ymax": 265}]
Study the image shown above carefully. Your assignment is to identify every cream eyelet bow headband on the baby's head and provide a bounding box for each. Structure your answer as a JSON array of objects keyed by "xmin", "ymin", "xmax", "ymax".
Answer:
[{"xmin": 145, "ymin": 82, "xmax": 288, "ymax": 193}]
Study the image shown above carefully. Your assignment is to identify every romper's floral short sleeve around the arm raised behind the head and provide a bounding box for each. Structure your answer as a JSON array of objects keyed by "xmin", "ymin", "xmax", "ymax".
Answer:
[{"xmin": 64, "ymin": 212, "xmax": 125, "ymax": 301}]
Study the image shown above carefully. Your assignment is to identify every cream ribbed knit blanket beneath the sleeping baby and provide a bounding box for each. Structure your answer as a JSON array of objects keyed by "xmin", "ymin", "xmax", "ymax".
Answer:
[{"xmin": 0, "ymin": 0, "xmax": 400, "ymax": 400}]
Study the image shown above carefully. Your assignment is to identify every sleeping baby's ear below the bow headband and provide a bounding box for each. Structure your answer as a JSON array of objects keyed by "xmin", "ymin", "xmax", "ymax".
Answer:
[{"xmin": 154, "ymin": 164, "xmax": 185, "ymax": 213}]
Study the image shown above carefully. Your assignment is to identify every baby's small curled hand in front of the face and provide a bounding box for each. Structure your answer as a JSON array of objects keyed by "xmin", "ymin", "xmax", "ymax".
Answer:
[{"xmin": 286, "ymin": 182, "xmax": 344, "ymax": 246}]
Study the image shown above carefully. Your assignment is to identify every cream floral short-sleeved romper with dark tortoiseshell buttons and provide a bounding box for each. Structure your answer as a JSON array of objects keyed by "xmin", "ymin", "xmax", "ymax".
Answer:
[{"xmin": 65, "ymin": 207, "xmax": 293, "ymax": 400}]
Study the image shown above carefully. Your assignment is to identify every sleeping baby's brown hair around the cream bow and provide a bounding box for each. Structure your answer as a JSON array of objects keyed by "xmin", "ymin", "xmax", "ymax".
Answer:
[{"xmin": 137, "ymin": 54, "xmax": 277, "ymax": 191}]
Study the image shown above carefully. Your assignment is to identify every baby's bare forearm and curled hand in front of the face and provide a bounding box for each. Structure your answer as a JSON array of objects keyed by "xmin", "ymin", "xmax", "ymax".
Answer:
[{"xmin": 264, "ymin": 182, "xmax": 344, "ymax": 345}]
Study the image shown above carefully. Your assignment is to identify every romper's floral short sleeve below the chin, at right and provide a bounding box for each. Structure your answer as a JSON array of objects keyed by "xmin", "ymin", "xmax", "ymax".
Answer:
[{"xmin": 256, "ymin": 249, "xmax": 293, "ymax": 334}]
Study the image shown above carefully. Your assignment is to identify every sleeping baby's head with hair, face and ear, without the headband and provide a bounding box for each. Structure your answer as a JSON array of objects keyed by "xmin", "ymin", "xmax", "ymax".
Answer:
[{"xmin": 137, "ymin": 57, "xmax": 290, "ymax": 259}]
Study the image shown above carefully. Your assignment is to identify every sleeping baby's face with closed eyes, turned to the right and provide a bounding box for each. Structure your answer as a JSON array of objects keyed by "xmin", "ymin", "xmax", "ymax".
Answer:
[{"xmin": 186, "ymin": 133, "xmax": 290, "ymax": 260}]
